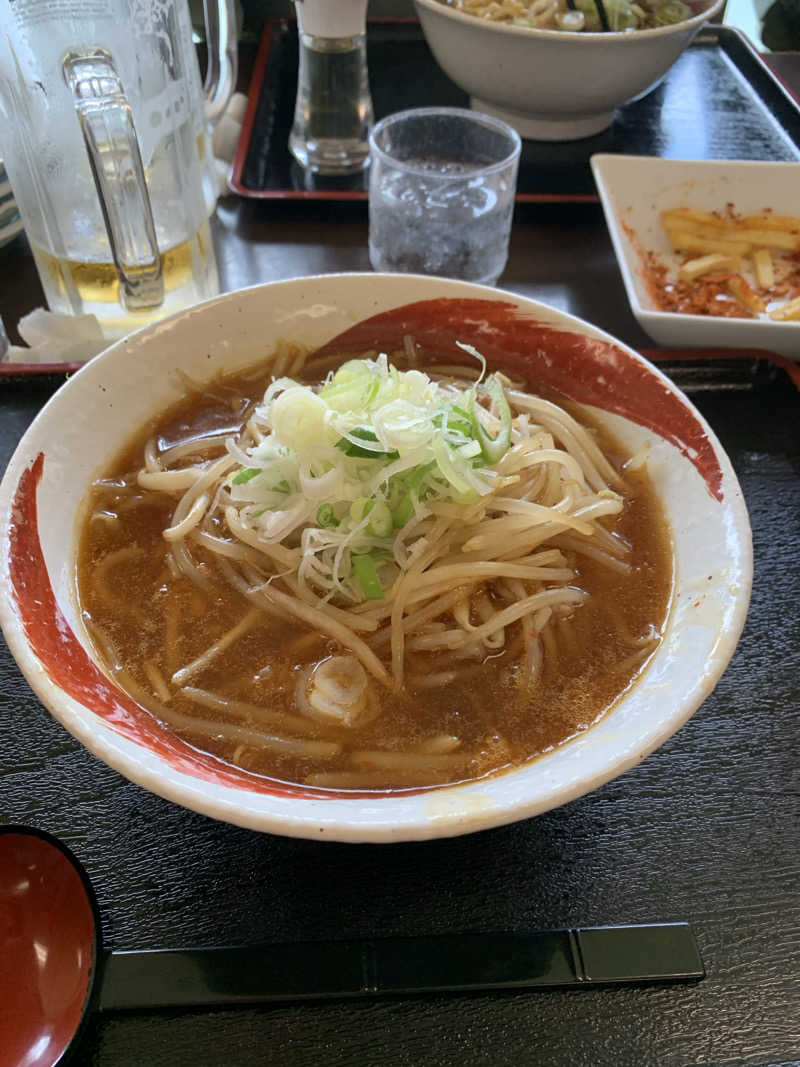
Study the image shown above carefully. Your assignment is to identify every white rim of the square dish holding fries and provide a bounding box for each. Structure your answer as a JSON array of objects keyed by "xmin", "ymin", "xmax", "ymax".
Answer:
[{"xmin": 589, "ymin": 153, "xmax": 800, "ymax": 328}]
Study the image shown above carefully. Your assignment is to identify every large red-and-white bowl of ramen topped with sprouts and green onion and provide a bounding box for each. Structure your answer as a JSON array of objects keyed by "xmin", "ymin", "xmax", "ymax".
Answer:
[{"xmin": 0, "ymin": 274, "xmax": 752, "ymax": 842}]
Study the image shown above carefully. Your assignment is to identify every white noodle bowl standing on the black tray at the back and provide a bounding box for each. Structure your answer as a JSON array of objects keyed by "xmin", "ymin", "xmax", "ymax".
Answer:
[{"xmin": 415, "ymin": 0, "xmax": 723, "ymax": 141}]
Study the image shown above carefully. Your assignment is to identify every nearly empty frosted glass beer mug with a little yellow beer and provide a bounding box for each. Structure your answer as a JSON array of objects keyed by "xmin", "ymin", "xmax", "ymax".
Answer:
[{"xmin": 0, "ymin": 0, "xmax": 236, "ymax": 338}]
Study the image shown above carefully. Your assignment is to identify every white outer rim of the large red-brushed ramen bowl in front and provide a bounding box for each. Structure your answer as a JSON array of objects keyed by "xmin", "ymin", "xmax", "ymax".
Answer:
[{"xmin": 0, "ymin": 272, "xmax": 753, "ymax": 843}]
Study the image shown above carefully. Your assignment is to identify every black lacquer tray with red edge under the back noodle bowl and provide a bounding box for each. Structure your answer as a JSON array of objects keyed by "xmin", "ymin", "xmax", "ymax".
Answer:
[{"xmin": 230, "ymin": 19, "xmax": 800, "ymax": 203}]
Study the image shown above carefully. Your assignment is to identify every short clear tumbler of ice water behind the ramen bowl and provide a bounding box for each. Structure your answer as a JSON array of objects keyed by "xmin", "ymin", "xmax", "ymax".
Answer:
[{"xmin": 369, "ymin": 108, "xmax": 521, "ymax": 285}]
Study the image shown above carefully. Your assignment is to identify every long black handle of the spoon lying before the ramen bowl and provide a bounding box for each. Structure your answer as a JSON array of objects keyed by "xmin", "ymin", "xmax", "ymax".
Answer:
[{"xmin": 99, "ymin": 922, "xmax": 705, "ymax": 1012}]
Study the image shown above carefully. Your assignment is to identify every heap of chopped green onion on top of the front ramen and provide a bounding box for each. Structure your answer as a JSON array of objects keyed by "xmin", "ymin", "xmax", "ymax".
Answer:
[{"xmin": 236, "ymin": 356, "xmax": 507, "ymax": 601}]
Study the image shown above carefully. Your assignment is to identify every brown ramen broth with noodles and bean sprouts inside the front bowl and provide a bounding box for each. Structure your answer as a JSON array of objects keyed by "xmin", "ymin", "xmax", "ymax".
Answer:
[{"xmin": 77, "ymin": 348, "xmax": 672, "ymax": 790}]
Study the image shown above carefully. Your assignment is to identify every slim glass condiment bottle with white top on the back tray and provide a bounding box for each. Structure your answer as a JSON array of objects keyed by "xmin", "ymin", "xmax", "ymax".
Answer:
[{"xmin": 289, "ymin": 0, "xmax": 374, "ymax": 174}]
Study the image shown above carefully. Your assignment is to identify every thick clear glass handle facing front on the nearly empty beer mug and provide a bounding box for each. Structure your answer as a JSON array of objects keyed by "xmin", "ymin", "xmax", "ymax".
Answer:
[{"xmin": 62, "ymin": 48, "xmax": 164, "ymax": 312}]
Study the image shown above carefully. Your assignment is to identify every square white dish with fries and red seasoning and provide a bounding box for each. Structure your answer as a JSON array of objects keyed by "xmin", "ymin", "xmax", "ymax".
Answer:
[{"xmin": 591, "ymin": 155, "xmax": 800, "ymax": 361}]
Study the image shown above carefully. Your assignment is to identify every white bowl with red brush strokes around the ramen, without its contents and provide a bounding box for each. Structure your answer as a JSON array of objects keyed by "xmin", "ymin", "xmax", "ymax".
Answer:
[{"xmin": 0, "ymin": 274, "xmax": 752, "ymax": 842}]
